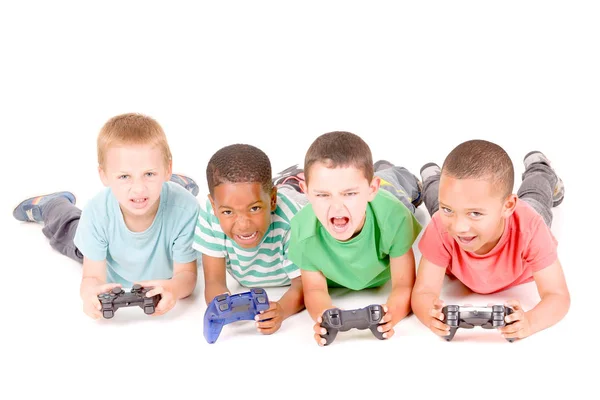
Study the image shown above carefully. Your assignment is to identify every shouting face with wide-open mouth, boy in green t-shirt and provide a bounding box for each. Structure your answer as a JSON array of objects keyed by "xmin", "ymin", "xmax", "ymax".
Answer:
[{"xmin": 301, "ymin": 163, "xmax": 379, "ymax": 241}]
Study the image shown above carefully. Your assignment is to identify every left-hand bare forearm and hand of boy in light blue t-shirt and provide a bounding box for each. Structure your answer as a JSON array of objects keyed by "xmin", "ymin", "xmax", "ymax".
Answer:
[{"xmin": 79, "ymin": 256, "xmax": 121, "ymax": 319}]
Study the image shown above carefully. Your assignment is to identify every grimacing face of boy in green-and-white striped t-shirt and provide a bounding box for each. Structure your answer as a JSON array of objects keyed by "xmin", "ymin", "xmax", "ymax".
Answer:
[{"xmin": 208, "ymin": 182, "xmax": 277, "ymax": 249}]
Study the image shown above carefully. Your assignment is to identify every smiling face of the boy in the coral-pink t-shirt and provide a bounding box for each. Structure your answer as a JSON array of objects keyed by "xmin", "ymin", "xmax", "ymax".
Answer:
[{"xmin": 439, "ymin": 174, "xmax": 517, "ymax": 254}]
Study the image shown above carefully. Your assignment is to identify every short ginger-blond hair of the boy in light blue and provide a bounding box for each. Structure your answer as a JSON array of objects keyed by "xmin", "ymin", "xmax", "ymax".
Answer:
[{"xmin": 97, "ymin": 113, "xmax": 171, "ymax": 166}]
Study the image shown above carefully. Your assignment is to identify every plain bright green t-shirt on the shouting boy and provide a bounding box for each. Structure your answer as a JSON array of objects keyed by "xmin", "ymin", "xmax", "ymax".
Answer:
[{"xmin": 288, "ymin": 190, "xmax": 422, "ymax": 290}]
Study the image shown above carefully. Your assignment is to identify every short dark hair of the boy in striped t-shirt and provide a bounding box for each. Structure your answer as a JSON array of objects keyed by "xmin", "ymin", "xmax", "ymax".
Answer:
[{"xmin": 206, "ymin": 144, "xmax": 273, "ymax": 195}]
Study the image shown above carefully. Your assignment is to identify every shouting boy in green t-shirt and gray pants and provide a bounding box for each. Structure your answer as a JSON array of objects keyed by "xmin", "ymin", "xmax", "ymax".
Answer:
[{"xmin": 288, "ymin": 132, "xmax": 422, "ymax": 346}]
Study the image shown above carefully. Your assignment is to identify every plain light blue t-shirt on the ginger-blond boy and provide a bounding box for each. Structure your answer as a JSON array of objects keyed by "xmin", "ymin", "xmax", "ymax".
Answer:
[{"xmin": 74, "ymin": 182, "xmax": 200, "ymax": 287}]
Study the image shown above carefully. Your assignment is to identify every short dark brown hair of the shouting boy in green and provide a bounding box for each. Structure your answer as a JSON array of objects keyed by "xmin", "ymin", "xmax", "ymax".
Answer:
[{"xmin": 304, "ymin": 131, "xmax": 373, "ymax": 183}]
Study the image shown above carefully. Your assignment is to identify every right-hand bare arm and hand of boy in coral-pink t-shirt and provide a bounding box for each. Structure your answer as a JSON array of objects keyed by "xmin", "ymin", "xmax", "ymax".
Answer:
[{"xmin": 500, "ymin": 260, "xmax": 571, "ymax": 339}]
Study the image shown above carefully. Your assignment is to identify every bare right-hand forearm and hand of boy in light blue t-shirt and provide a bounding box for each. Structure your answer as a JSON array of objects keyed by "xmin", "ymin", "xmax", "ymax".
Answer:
[{"xmin": 138, "ymin": 260, "xmax": 198, "ymax": 316}]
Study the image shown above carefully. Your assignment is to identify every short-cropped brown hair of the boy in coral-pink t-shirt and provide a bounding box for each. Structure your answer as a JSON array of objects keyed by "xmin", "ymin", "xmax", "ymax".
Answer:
[{"xmin": 442, "ymin": 140, "xmax": 515, "ymax": 197}]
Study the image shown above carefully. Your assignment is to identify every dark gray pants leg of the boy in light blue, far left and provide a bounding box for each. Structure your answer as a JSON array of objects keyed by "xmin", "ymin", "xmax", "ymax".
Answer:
[{"xmin": 42, "ymin": 197, "xmax": 83, "ymax": 263}]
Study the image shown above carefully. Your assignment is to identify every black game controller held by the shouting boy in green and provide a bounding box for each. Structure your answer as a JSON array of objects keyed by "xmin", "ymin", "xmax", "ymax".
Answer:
[{"xmin": 320, "ymin": 304, "xmax": 385, "ymax": 346}]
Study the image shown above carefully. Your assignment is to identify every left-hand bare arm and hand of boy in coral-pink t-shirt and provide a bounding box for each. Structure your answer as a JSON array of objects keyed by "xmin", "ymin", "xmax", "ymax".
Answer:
[{"xmin": 411, "ymin": 256, "xmax": 450, "ymax": 336}]
